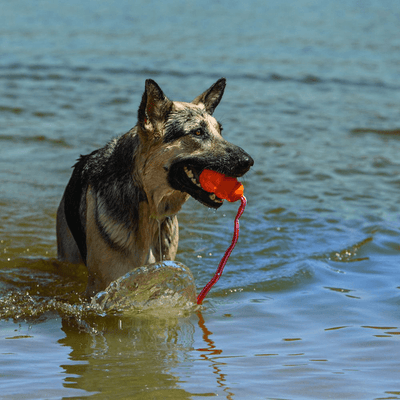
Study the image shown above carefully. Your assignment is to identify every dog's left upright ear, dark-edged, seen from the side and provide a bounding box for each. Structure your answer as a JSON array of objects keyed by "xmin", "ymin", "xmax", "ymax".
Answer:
[{"xmin": 138, "ymin": 79, "xmax": 172, "ymax": 139}]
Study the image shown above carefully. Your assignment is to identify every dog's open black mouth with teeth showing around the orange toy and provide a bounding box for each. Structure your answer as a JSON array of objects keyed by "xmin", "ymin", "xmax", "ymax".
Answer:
[{"xmin": 169, "ymin": 162, "xmax": 224, "ymax": 209}]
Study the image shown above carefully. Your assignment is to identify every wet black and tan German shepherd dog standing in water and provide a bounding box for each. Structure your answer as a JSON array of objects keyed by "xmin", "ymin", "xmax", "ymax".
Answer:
[{"xmin": 57, "ymin": 78, "xmax": 254, "ymax": 297}]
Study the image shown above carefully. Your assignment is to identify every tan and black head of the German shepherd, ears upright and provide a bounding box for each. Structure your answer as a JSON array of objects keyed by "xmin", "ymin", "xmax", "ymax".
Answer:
[{"xmin": 138, "ymin": 78, "xmax": 254, "ymax": 208}]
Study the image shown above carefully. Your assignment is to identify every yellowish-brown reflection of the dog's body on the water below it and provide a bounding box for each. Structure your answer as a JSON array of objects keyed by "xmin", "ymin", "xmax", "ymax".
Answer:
[{"xmin": 59, "ymin": 315, "xmax": 194, "ymax": 399}]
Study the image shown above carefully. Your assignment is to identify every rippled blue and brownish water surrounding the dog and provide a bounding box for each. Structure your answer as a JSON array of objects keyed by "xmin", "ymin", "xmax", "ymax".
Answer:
[{"xmin": 0, "ymin": 0, "xmax": 400, "ymax": 399}]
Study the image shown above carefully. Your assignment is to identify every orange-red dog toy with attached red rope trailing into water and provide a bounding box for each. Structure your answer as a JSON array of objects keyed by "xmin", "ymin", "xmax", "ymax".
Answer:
[{"xmin": 197, "ymin": 169, "xmax": 247, "ymax": 304}]
